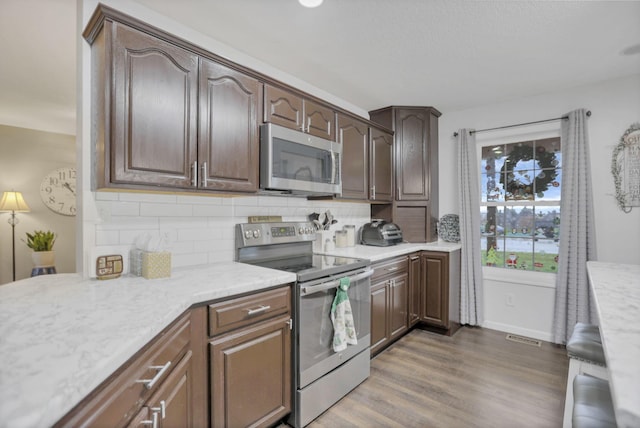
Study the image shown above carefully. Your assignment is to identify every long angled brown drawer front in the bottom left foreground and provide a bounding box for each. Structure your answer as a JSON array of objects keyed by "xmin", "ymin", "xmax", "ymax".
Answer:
[{"xmin": 55, "ymin": 313, "xmax": 191, "ymax": 427}]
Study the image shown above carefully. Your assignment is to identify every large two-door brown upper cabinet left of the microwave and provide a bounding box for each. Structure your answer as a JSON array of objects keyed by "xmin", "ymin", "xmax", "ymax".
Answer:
[{"xmin": 85, "ymin": 5, "xmax": 262, "ymax": 192}]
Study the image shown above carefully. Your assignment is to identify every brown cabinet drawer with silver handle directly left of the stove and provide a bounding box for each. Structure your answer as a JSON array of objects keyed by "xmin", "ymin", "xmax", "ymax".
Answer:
[{"xmin": 209, "ymin": 286, "xmax": 291, "ymax": 336}]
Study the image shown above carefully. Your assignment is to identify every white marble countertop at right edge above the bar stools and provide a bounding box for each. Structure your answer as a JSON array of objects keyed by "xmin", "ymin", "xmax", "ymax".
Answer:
[{"xmin": 587, "ymin": 262, "xmax": 640, "ymax": 428}]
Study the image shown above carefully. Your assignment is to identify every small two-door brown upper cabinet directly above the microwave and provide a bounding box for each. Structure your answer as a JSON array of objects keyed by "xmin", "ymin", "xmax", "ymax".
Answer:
[{"xmin": 264, "ymin": 85, "xmax": 336, "ymax": 141}]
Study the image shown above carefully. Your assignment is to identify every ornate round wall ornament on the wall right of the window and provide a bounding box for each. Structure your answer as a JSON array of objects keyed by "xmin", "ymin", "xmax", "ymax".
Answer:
[{"xmin": 611, "ymin": 122, "xmax": 640, "ymax": 213}]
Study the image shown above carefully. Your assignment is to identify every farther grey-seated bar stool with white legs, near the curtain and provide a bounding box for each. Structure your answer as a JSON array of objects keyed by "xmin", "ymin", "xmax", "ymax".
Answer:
[{"xmin": 562, "ymin": 323, "xmax": 609, "ymax": 428}]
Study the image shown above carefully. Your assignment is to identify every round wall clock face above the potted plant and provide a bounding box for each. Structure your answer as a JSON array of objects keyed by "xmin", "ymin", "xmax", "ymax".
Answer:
[{"xmin": 40, "ymin": 167, "xmax": 76, "ymax": 215}]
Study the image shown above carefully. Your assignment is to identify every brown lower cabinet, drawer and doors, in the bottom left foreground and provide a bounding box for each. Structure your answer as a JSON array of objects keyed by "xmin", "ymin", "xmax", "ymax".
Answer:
[{"xmin": 54, "ymin": 310, "xmax": 208, "ymax": 427}]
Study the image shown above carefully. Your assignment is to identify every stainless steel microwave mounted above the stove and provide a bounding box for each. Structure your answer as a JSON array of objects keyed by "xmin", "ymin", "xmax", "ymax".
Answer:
[{"xmin": 260, "ymin": 123, "xmax": 342, "ymax": 195}]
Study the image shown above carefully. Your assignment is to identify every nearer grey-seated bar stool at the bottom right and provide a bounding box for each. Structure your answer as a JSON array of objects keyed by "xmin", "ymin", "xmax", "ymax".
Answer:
[{"xmin": 571, "ymin": 375, "xmax": 617, "ymax": 428}]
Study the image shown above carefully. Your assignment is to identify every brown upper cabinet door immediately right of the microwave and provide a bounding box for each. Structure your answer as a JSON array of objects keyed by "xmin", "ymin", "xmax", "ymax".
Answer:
[{"xmin": 338, "ymin": 114, "xmax": 369, "ymax": 200}]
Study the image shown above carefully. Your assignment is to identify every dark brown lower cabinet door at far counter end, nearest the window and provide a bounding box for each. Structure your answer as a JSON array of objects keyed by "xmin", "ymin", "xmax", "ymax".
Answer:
[{"xmin": 421, "ymin": 252, "xmax": 449, "ymax": 328}]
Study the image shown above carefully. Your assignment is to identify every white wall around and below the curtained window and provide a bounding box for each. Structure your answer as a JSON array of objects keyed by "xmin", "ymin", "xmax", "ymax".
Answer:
[{"xmin": 439, "ymin": 75, "xmax": 640, "ymax": 340}]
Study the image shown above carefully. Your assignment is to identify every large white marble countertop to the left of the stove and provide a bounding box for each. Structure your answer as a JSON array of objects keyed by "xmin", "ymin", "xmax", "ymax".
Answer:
[{"xmin": 0, "ymin": 262, "xmax": 296, "ymax": 428}]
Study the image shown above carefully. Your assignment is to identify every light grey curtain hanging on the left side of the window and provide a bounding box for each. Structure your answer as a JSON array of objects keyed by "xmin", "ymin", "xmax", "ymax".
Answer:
[{"xmin": 458, "ymin": 129, "xmax": 484, "ymax": 325}]
